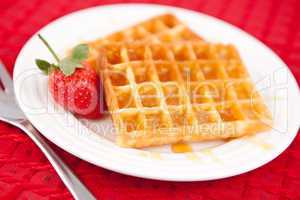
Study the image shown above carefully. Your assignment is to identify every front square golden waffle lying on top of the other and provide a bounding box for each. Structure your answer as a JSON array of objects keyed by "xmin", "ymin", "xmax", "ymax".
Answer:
[{"xmin": 98, "ymin": 41, "xmax": 272, "ymax": 148}]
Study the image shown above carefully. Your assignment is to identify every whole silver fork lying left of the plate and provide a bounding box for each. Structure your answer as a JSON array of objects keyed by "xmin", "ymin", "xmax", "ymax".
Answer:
[{"xmin": 0, "ymin": 61, "xmax": 96, "ymax": 200}]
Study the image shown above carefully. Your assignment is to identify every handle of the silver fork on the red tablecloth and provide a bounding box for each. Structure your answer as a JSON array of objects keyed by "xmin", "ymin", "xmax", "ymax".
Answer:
[{"xmin": 16, "ymin": 120, "xmax": 96, "ymax": 200}]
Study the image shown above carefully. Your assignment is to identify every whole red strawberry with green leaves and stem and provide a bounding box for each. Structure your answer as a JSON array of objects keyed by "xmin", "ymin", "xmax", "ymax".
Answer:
[{"xmin": 36, "ymin": 35, "xmax": 101, "ymax": 119}]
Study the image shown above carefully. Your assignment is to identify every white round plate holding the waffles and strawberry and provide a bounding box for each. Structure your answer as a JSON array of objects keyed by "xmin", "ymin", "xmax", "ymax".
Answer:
[{"xmin": 14, "ymin": 4, "xmax": 300, "ymax": 181}]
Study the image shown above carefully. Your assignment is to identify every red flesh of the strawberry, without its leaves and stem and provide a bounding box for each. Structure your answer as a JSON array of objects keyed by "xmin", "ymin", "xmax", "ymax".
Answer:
[{"xmin": 49, "ymin": 65, "xmax": 101, "ymax": 119}]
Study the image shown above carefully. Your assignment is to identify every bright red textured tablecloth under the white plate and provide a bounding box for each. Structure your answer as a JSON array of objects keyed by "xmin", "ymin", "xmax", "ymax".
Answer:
[{"xmin": 0, "ymin": 0, "xmax": 300, "ymax": 200}]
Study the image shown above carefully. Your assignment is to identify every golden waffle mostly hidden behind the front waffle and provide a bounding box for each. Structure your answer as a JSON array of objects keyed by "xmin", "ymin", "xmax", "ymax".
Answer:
[{"xmin": 89, "ymin": 14, "xmax": 202, "ymax": 67}]
